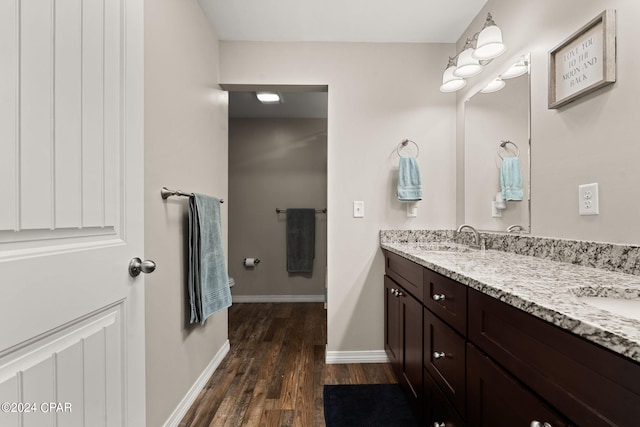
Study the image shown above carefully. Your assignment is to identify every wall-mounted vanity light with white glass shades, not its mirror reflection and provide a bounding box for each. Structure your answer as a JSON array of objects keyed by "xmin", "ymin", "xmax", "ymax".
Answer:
[{"xmin": 440, "ymin": 13, "xmax": 506, "ymax": 92}]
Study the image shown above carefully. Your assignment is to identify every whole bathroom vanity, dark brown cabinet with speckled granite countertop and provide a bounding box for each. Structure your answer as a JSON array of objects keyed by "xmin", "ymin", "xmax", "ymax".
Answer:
[{"xmin": 381, "ymin": 232, "xmax": 640, "ymax": 427}]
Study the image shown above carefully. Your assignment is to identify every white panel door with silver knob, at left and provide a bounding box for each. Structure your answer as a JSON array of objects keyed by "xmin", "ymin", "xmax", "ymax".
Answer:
[{"xmin": 0, "ymin": 0, "xmax": 145, "ymax": 427}]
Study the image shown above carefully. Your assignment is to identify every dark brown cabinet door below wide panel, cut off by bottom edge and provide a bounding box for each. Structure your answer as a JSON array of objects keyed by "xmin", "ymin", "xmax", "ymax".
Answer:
[{"xmin": 467, "ymin": 344, "xmax": 573, "ymax": 427}]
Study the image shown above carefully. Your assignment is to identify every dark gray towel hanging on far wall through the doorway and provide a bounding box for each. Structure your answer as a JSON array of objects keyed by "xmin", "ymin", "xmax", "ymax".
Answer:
[{"xmin": 287, "ymin": 209, "xmax": 316, "ymax": 273}]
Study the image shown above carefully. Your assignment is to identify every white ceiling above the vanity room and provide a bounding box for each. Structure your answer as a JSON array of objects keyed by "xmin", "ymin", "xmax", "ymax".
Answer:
[{"xmin": 198, "ymin": 0, "xmax": 487, "ymax": 43}]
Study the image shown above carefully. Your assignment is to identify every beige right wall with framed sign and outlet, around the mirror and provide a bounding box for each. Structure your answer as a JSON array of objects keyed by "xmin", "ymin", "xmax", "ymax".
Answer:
[{"xmin": 457, "ymin": 0, "xmax": 640, "ymax": 244}]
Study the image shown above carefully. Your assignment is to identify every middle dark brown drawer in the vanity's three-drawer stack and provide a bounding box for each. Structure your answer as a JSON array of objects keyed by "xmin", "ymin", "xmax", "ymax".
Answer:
[{"xmin": 423, "ymin": 308, "xmax": 466, "ymax": 415}]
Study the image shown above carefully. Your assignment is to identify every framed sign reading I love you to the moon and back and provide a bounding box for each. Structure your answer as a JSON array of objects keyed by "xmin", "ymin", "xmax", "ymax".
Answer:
[{"xmin": 549, "ymin": 10, "xmax": 616, "ymax": 109}]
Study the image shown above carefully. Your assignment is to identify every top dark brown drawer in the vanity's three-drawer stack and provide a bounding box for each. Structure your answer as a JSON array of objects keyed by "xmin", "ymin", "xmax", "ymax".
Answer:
[{"xmin": 423, "ymin": 268, "xmax": 467, "ymax": 335}]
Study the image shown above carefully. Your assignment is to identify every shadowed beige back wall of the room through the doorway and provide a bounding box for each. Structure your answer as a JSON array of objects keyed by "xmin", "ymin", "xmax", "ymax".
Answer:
[{"xmin": 229, "ymin": 115, "xmax": 327, "ymax": 300}]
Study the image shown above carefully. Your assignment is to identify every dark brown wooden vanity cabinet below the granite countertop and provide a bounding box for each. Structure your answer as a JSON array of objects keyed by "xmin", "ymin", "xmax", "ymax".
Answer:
[{"xmin": 384, "ymin": 247, "xmax": 640, "ymax": 427}]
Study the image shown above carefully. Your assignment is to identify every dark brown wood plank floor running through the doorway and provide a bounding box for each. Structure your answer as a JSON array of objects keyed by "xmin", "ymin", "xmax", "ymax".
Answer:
[{"xmin": 180, "ymin": 303, "xmax": 396, "ymax": 427}]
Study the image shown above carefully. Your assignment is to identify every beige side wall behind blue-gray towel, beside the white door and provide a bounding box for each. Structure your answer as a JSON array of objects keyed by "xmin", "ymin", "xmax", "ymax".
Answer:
[{"xmin": 144, "ymin": 0, "xmax": 228, "ymax": 427}]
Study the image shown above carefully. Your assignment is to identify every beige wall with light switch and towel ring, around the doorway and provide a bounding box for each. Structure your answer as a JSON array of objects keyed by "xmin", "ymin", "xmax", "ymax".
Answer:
[{"xmin": 220, "ymin": 42, "xmax": 455, "ymax": 351}]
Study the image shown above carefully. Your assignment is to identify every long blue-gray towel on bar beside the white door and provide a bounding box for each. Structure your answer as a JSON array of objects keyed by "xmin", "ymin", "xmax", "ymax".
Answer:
[{"xmin": 188, "ymin": 194, "xmax": 231, "ymax": 324}]
